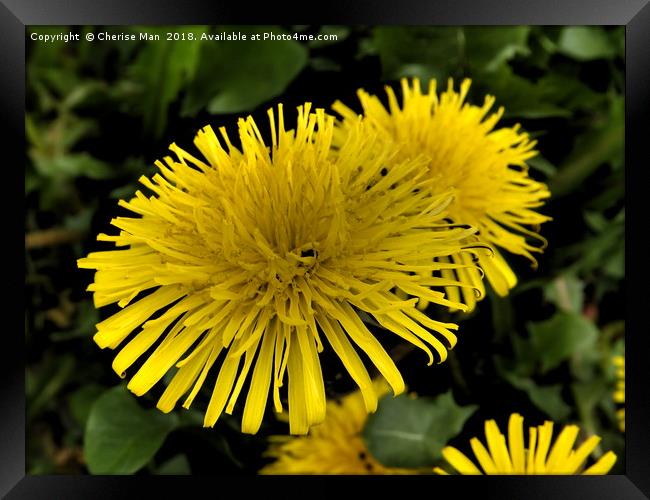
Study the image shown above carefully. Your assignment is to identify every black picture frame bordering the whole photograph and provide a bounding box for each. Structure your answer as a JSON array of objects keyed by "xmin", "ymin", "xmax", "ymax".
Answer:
[{"xmin": 6, "ymin": 0, "xmax": 650, "ymax": 500}]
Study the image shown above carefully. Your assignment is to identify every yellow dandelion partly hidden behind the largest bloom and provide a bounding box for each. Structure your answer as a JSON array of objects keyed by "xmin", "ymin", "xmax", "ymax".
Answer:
[{"xmin": 332, "ymin": 79, "xmax": 550, "ymax": 309}]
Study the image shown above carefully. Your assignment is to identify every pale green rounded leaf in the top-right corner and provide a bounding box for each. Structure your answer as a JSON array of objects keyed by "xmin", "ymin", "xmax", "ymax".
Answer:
[{"xmin": 558, "ymin": 26, "xmax": 616, "ymax": 61}]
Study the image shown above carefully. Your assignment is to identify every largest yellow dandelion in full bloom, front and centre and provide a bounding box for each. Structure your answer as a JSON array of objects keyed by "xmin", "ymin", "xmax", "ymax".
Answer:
[{"xmin": 78, "ymin": 104, "xmax": 473, "ymax": 434}]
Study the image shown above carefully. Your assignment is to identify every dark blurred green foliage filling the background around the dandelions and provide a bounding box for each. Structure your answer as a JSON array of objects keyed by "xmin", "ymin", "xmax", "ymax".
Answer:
[{"xmin": 25, "ymin": 26, "xmax": 625, "ymax": 474}]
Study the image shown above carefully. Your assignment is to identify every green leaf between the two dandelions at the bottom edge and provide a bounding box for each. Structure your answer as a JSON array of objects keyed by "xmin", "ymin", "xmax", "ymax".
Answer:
[{"xmin": 363, "ymin": 391, "xmax": 478, "ymax": 467}]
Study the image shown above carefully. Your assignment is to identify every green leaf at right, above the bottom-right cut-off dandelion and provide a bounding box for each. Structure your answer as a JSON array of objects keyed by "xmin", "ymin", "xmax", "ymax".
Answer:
[{"xmin": 528, "ymin": 311, "xmax": 598, "ymax": 372}]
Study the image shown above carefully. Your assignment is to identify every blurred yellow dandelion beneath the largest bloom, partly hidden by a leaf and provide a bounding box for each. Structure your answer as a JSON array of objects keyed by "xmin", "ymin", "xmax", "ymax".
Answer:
[{"xmin": 260, "ymin": 383, "xmax": 410, "ymax": 474}]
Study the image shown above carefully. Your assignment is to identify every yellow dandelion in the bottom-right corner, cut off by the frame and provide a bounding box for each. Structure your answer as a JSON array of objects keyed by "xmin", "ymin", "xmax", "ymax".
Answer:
[{"xmin": 434, "ymin": 413, "xmax": 616, "ymax": 475}]
